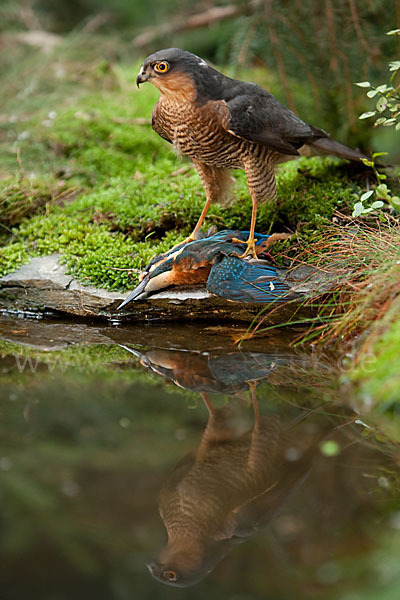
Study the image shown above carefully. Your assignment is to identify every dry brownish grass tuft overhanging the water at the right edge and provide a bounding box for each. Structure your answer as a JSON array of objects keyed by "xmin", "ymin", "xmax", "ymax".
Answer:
[{"xmin": 245, "ymin": 217, "xmax": 400, "ymax": 348}]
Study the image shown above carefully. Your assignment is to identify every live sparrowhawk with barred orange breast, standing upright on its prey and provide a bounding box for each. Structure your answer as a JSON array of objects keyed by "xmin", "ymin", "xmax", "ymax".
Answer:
[{"xmin": 136, "ymin": 48, "xmax": 364, "ymax": 256}]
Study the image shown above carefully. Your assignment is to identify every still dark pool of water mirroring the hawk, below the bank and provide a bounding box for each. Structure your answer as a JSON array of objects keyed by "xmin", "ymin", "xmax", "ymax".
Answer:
[{"xmin": 0, "ymin": 317, "xmax": 400, "ymax": 600}]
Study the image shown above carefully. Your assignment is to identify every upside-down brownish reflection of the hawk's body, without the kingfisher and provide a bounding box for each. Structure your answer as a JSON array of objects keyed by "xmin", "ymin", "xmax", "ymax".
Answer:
[{"xmin": 148, "ymin": 394, "xmax": 322, "ymax": 587}]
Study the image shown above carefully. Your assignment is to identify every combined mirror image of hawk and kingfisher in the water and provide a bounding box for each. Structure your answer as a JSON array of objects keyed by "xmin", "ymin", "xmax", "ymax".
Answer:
[{"xmin": 121, "ymin": 346, "xmax": 352, "ymax": 587}]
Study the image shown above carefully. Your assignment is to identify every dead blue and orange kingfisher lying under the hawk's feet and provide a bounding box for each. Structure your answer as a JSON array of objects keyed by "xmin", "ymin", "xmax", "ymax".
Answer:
[{"xmin": 118, "ymin": 230, "xmax": 294, "ymax": 310}]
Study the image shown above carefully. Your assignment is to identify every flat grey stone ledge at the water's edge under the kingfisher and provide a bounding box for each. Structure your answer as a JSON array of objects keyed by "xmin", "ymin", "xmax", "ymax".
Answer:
[{"xmin": 0, "ymin": 254, "xmax": 340, "ymax": 323}]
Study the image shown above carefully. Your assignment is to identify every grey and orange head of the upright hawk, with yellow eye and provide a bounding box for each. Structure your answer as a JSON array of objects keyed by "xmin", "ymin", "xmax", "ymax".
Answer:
[{"xmin": 136, "ymin": 48, "xmax": 220, "ymax": 100}]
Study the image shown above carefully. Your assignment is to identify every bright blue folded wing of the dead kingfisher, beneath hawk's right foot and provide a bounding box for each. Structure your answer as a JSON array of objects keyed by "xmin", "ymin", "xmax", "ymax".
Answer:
[{"xmin": 206, "ymin": 255, "xmax": 290, "ymax": 303}]
